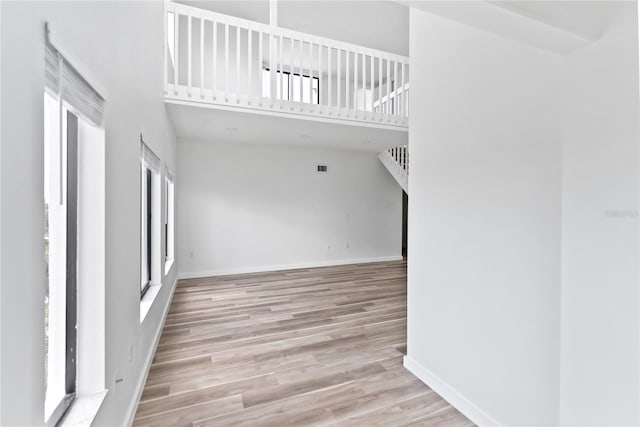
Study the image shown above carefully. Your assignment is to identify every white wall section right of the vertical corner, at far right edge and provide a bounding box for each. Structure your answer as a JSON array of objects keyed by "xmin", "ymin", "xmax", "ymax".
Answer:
[{"xmin": 561, "ymin": 2, "xmax": 640, "ymax": 425}]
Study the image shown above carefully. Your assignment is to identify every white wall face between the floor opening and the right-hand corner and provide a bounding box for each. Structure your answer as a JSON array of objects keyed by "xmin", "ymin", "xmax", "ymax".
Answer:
[{"xmin": 407, "ymin": 9, "xmax": 562, "ymax": 425}]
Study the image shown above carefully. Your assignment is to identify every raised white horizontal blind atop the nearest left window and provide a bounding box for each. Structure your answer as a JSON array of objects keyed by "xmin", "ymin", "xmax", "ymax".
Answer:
[{"xmin": 44, "ymin": 25, "xmax": 104, "ymax": 126}]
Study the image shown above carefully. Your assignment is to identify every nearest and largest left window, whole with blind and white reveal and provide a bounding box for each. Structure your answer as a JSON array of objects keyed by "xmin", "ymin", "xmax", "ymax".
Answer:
[{"xmin": 43, "ymin": 30, "xmax": 105, "ymax": 425}]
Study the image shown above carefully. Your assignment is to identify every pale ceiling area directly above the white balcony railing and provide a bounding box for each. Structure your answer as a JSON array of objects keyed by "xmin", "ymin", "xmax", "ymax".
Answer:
[{"xmin": 178, "ymin": 0, "xmax": 409, "ymax": 56}]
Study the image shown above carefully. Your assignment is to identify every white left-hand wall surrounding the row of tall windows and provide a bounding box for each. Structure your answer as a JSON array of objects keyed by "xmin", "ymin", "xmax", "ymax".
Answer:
[{"xmin": 0, "ymin": 2, "xmax": 179, "ymax": 426}]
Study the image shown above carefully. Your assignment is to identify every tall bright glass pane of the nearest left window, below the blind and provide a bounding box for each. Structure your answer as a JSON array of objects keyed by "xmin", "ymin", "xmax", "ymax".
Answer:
[{"xmin": 44, "ymin": 94, "xmax": 78, "ymax": 425}]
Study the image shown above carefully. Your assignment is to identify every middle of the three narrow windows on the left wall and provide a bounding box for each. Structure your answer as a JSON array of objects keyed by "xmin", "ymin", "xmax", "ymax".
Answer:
[{"xmin": 140, "ymin": 142, "xmax": 161, "ymax": 298}]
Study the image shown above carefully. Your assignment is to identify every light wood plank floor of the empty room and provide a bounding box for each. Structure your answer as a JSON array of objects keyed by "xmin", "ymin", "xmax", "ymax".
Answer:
[{"xmin": 134, "ymin": 261, "xmax": 473, "ymax": 427}]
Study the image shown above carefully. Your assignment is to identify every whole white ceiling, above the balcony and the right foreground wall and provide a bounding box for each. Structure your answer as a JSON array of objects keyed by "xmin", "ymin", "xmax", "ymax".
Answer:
[{"xmin": 178, "ymin": 0, "xmax": 636, "ymax": 55}]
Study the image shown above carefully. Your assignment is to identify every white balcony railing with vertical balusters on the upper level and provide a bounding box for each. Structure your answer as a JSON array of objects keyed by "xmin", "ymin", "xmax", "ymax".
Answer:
[{"xmin": 164, "ymin": 2, "xmax": 409, "ymax": 127}]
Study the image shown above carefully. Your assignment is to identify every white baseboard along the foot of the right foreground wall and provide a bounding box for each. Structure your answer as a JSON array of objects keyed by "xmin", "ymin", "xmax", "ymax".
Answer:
[{"xmin": 404, "ymin": 356, "xmax": 503, "ymax": 426}]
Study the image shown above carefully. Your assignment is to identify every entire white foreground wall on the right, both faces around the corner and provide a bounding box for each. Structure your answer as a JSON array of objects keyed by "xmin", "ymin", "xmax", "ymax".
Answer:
[{"xmin": 407, "ymin": 2, "xmax": 640, "ymax": 425}]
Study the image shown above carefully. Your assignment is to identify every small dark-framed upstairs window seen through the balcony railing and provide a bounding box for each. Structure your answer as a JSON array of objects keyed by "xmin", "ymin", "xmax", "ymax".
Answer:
[{"xmin": 262, "ymin": 68, "xmax": 320, "ymax": 104}]
